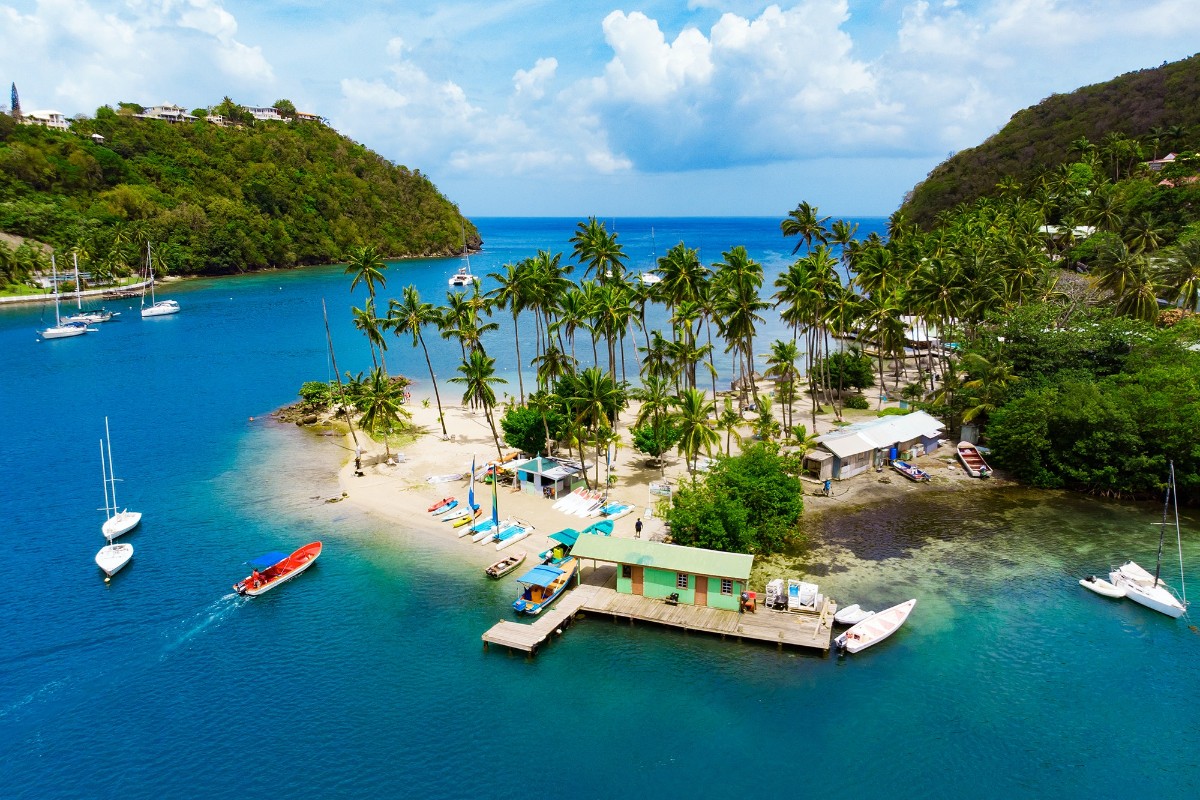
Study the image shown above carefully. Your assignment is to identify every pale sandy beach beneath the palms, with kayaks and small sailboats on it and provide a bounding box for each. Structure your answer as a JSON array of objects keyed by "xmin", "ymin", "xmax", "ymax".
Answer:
[{"xmin": 324, "ymin": 374, "xmax": 1004, "ymax": 575}]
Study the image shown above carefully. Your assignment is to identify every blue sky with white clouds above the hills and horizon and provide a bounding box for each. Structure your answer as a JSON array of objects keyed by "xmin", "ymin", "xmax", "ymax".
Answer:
[{"xmin": 0, "ymin": 0, "xmax": 1200, "ymax": 217}]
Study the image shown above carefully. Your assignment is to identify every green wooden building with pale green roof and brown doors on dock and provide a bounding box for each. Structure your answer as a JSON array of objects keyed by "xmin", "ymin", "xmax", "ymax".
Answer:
[{"xmin": 571, "ymin": 534, "xmax": 754, "ymax": 612}]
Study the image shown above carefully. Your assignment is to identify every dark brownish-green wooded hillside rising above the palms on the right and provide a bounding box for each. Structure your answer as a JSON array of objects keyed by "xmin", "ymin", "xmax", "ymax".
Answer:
[{"xmin": 901, "ymin": 55, "xmax": 1200, "ymax": 224}]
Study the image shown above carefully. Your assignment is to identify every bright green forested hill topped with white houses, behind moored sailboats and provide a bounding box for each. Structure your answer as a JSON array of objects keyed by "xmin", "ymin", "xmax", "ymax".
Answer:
[{"xmin": 0, "ymin": 107, "xmax": 480, "ymax": 280}]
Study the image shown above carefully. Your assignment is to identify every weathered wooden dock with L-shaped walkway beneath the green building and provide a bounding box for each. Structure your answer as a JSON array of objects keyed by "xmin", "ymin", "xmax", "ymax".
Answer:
[{"xmin": 484, "ymin": 567, "xmax": 838, "ymax": 655}]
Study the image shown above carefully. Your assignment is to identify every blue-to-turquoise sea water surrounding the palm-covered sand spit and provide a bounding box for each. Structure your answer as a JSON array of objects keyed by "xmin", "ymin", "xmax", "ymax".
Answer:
[{"xmin": 0, "ymin": 218, "xmax": 1200, "ymax": 800}]
